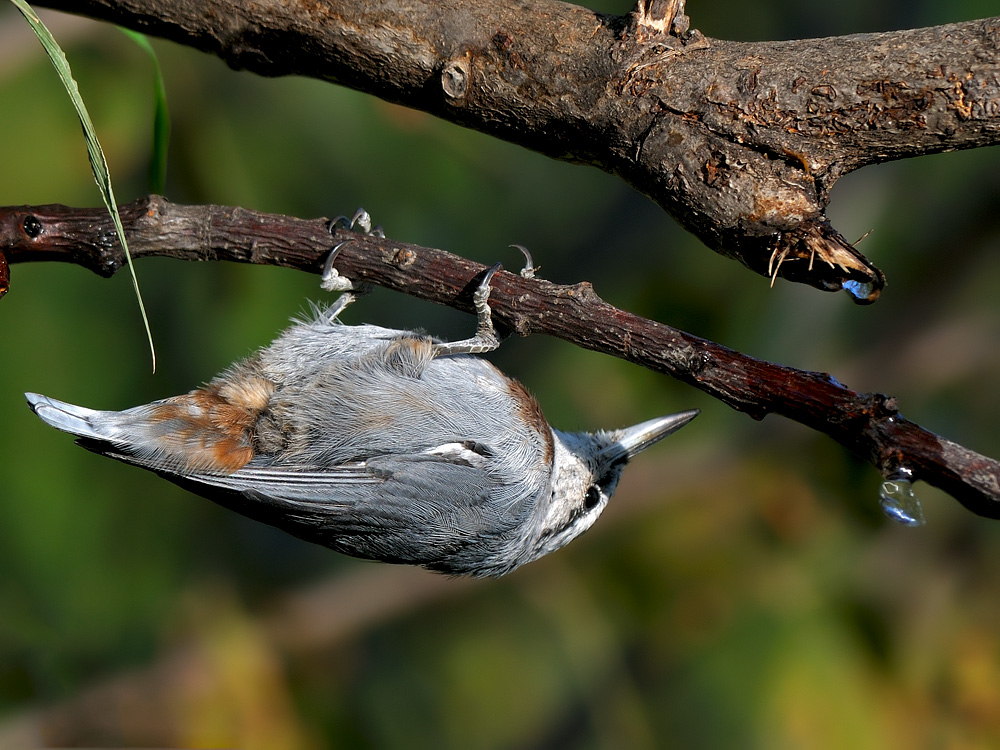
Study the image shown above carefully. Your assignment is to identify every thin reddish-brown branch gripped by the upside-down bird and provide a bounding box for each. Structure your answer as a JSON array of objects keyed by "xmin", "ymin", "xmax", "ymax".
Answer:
[{"xmin": 0, "ymin": 196, "xmax": 1000, "ymax": 518}]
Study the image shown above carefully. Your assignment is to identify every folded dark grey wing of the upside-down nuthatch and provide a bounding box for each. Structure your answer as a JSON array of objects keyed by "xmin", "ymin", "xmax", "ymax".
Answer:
[{"xmin": 163, "ymin": 452, "xmax": 523, "ymax": 572}]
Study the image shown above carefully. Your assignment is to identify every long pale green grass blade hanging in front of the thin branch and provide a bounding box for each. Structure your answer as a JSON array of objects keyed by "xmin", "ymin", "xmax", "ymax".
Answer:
[{"xmin": 10, "ymin": 0, "xmax": 156, "ymax": 372}]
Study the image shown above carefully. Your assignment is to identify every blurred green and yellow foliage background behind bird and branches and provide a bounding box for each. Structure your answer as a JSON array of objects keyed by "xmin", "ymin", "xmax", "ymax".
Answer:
[{"xmin": 0, "ymin": 0, "xmax": 1000, "ymax": 749}]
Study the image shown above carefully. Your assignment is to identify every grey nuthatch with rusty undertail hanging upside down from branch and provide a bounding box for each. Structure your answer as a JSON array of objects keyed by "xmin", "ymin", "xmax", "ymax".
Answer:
[{"xmin": 26, "ymin": 212, "xmax": 698, "ymax": 576}]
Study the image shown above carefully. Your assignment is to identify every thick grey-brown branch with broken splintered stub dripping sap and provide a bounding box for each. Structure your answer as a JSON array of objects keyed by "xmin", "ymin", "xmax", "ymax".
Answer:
[{"xmin": 27, "ymin": 0, "xmax": 1000, "ymax": 302}]
